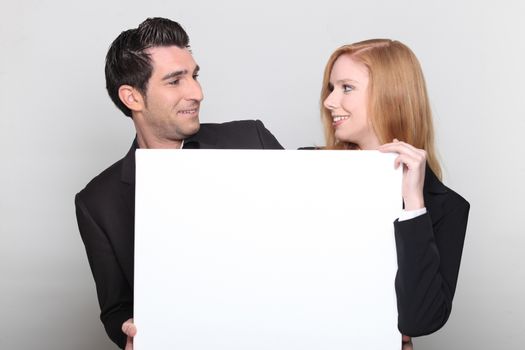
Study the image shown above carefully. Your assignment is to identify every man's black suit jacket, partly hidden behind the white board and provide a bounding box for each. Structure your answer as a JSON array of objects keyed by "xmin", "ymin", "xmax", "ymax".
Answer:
[{"xmin": 75, "ymin": 120, "xmax": 282, "ymax": 348}]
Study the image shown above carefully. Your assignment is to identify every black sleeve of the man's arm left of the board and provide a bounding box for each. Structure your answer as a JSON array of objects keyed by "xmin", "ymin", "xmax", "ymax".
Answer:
[{"xmin": 75, "ymin": 194, "xmax": 133, "ymax": 348}]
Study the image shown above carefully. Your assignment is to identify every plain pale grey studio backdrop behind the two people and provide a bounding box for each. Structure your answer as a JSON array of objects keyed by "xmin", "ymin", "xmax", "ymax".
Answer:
[{"xmin": 0, "ymin": 0, "xmax": 525, "ymax": 350}]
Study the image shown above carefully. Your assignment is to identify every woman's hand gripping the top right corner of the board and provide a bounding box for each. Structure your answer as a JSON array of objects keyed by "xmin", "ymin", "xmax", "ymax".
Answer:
[{"xmin": 378, "ymin": 139, "xmax": 427, "ymax": 210}]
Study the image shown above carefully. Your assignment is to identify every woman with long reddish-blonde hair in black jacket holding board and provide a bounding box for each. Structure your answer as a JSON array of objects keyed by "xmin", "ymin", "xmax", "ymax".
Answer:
[{"xmin": 321, "ymin": 39, "xmax": 469, "ymax": 348}]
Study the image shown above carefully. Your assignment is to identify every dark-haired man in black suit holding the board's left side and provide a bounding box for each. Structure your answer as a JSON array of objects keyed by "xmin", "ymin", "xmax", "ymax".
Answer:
[{"xmin": 75, "ymin": 18, "xmax": 282, "ymax": 349}]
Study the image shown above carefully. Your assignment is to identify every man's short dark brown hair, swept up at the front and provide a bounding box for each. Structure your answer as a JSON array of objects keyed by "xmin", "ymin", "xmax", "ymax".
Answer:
[{"xmin": 105, "ymin": 17, "xmax": 190, "ymax": 117}]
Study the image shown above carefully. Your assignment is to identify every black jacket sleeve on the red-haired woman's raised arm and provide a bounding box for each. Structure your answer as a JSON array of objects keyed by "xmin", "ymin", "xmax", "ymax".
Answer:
[{"xmin": 394, "ymin": 201, "xmax": 469, "ymax": 337}]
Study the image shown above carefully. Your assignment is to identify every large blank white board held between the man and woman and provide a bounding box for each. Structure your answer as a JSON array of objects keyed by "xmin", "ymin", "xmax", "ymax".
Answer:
[{"xmin": 134, "ymin": 150, "xmax": 402, "ymax": 350}]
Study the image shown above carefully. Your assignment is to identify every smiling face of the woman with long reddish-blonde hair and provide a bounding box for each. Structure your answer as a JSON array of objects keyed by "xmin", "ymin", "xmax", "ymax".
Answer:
[{"xmin": 324, "ymin": 55, "xmax": 380, "ymax": 149}]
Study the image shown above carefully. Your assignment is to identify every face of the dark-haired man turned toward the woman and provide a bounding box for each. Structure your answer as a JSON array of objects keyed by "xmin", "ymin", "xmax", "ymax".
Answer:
[{"xmin": 135, "ymin": 46, "xmax": 203, "ymax": 144}]
